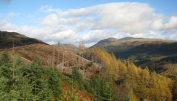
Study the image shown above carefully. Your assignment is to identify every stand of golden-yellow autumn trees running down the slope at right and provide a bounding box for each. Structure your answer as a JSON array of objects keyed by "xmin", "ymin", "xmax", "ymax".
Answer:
[{"xmin": 92, "ymin": 48, "xmax": 172, "ymax": 101}]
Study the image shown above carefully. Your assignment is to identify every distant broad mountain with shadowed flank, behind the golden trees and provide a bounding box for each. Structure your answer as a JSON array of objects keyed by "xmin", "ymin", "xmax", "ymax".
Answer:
[{"xmin": 91, "ymin": 37, "xmax": 177, "ymax": 74}]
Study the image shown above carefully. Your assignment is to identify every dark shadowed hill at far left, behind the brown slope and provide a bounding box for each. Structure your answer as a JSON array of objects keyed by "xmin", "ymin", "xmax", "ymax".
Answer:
[{"xmin": 0, "ymin": 31, "xmax": 46, "ymax": 49}]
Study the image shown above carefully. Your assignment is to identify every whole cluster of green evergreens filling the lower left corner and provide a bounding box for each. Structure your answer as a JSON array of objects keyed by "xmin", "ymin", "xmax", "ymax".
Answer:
[{"xmin": 0, "ymin": 52, "xmax": 62, "ymax": 101}]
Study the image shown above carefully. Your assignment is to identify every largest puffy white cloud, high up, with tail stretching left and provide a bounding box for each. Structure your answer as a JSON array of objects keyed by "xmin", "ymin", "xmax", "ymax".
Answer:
[{"xmin": 42, "ymin": 2, "xmax": 156, "ymax": 33}]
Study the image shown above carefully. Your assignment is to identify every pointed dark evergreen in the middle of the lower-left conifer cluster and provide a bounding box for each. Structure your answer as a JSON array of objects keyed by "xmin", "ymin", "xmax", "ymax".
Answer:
[{"xmin": 24, "ymin": 59, "xmax": 52, "ymax": 101}]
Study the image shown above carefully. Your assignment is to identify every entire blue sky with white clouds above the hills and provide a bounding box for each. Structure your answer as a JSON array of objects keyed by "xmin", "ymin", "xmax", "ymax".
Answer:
[{"xmin": 0, "ymin": 0, "xmax": 177, "ymax": 46}]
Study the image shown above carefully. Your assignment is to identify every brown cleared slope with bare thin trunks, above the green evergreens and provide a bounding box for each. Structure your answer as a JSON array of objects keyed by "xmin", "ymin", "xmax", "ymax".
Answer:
[{"xmin": 0, "ymin": 44, "xmax": 99, "ymax": 79}]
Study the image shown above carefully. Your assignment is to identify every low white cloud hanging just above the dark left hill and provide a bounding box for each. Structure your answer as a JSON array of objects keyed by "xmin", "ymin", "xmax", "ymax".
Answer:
[{"xmin": 0, "ymin": 21, "xmax": 76, "ymax": 44}]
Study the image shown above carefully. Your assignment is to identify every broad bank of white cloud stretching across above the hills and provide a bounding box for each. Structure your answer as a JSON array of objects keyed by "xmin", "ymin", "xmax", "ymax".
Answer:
[{"xmin": 0, "ymin": 2, "xmax": 177, "ymax": 44}]
